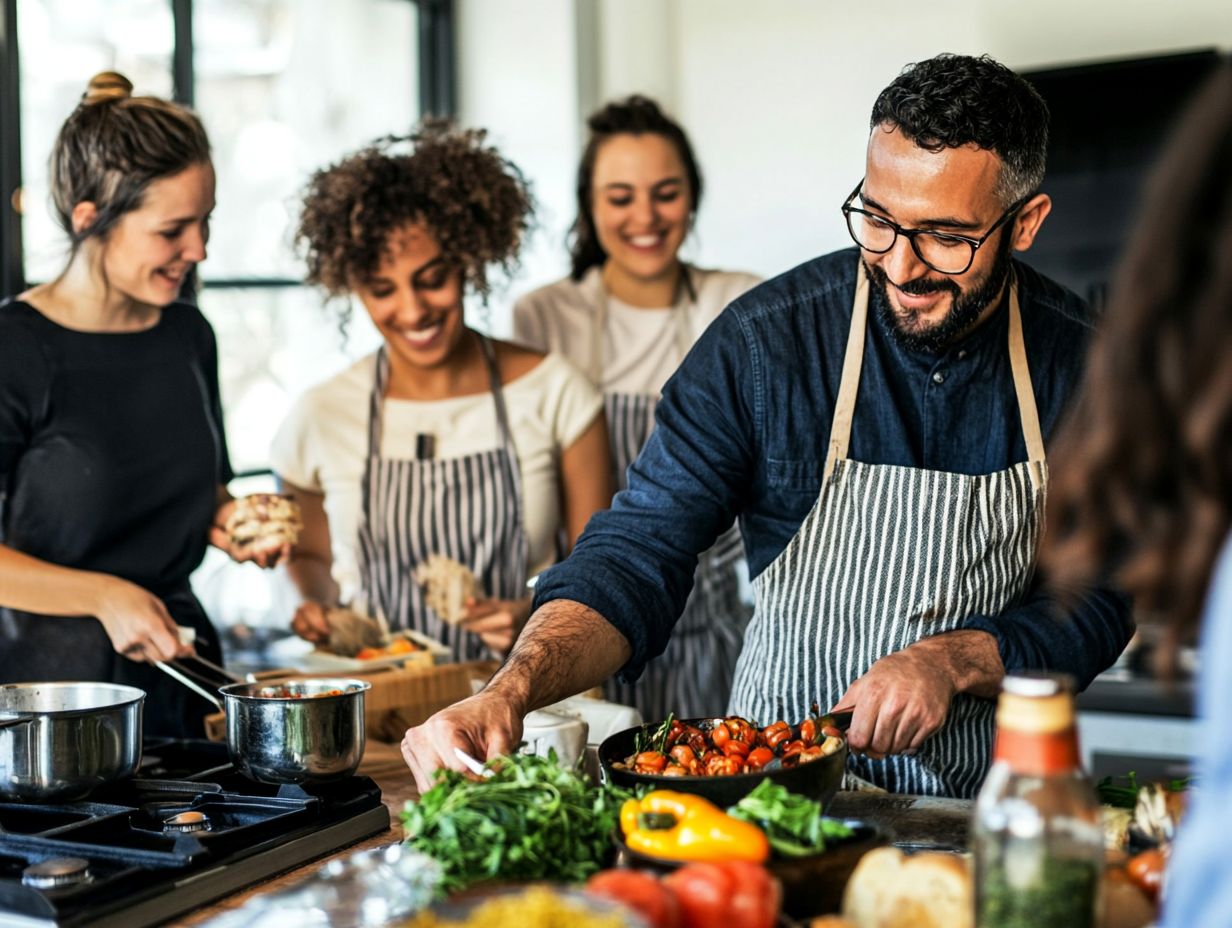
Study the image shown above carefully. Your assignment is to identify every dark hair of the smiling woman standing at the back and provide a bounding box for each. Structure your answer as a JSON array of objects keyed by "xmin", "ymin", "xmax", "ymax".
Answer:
[{"xmin": 569, "ymin": 94, "xmax": 701, "ymax": 280}]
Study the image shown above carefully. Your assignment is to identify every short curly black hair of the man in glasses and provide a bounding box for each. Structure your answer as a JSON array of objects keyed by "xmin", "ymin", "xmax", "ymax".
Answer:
[{"xmin": 869, "ymin": 54, "xmax": 1048, "ymax": 206}]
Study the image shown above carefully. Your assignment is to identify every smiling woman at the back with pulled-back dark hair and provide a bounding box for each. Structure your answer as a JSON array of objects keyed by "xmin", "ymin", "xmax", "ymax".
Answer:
[{"xmin": 514, "ymin": 96, "xmax": 758, "ymax": 718}]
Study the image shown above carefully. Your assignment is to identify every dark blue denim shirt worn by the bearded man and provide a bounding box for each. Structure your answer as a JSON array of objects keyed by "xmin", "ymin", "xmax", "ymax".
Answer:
[{"xmin": 535, "ymin": 249, "xmax": 1132, "ymax": 686}]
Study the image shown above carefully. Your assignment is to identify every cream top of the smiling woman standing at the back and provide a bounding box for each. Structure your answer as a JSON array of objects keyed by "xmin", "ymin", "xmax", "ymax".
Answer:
[{"xmin": 514, "ymin": 266, "xmax": 761, "ymax": 396}]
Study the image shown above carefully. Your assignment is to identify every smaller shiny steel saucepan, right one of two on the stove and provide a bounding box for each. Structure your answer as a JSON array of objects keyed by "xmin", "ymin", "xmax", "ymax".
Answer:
[{"xmin": 218, "ymin": 679, "xmax": 371, "ymax": 784}]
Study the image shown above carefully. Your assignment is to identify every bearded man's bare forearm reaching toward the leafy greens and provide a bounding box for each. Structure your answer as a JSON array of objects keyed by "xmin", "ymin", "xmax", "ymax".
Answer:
[{"xmin": 488, "ymin": 599, "xmax": 632, "ymax": 715}]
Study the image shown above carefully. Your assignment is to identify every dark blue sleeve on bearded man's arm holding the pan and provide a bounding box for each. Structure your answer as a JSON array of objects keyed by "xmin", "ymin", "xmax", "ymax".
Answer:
[{"xmin": 962, "ymin": 579, "xmax": 1133, "ymax": 690}]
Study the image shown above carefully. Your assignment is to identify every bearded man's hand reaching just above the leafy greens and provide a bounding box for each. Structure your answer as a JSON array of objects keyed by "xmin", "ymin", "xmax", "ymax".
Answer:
[{"xmin": 402, "ymin": 689, "xmax": 524, "ymax": 792}]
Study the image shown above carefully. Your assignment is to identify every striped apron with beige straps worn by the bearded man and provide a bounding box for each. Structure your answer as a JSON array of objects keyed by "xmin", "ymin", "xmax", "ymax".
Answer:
[{"xmin": 732, "ymin": 263, "xmax": 1047, "ymax": 797}]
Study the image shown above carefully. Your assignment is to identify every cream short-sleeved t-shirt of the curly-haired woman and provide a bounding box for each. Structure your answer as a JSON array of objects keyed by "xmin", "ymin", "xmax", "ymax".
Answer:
[{"xmin": 270, "ymin": 354, "xmax": 602, "ymax": 603}]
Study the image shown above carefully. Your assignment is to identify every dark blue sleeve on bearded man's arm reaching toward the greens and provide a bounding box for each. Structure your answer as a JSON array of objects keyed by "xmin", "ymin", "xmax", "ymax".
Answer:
[{"xmin": 535, "ymin": 309, "xmax": 759, "ymax": 680}]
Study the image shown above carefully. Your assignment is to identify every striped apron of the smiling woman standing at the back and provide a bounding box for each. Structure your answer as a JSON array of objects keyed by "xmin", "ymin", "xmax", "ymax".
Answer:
[{"xmin": 589, "ymin": 269, "xmax": 749, "ymax": 721}]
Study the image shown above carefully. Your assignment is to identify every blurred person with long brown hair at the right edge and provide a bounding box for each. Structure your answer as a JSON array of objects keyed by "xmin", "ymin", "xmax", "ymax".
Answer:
[{"xmin": 1040, "ymin": 64, "xmax": 1232, "ymax": 928}]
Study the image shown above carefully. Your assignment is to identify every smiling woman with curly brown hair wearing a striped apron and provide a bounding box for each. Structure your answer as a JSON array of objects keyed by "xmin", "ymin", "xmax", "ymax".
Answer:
[{"xmin": 271, "ymin": 122, "xmax": 611, "ymax": 659}]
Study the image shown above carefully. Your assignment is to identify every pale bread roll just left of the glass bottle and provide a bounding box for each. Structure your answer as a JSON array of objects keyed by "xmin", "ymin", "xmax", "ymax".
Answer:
[{"xmin": 843, "ymin": 848, "xmax": 975, "ymax": 928}]
